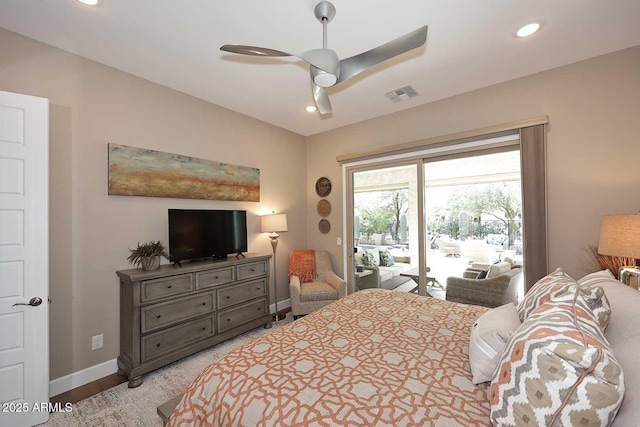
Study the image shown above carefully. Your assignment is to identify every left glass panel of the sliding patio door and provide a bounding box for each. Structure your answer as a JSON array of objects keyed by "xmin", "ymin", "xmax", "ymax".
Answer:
[{"xmin": 348, "ymin": 161, "xmax": 424, "ymax": 293}]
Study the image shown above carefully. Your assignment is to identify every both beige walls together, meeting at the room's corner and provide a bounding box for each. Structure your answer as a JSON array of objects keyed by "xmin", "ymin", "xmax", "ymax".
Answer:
[{"xmin": 0, "ymin": 25, "xmax": 640, "ymax": 379}]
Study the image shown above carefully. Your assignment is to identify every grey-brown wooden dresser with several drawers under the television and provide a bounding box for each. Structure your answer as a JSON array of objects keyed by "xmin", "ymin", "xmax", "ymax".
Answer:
[{"xmin": 116, "ymin": 253, "xmax": 272, "ymax": 387}]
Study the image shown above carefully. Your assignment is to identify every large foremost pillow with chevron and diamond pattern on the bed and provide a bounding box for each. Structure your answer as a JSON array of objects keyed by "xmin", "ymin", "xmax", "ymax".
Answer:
[{"xmin": 490, "ymin": 284, "xmax": 625, "ymax": 426}]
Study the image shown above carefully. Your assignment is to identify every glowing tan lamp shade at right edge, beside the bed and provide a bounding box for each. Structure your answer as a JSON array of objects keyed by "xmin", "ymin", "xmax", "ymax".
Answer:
[{"xmin": 598, "ymin": 215, "xmax": 640, "ymax": 259}]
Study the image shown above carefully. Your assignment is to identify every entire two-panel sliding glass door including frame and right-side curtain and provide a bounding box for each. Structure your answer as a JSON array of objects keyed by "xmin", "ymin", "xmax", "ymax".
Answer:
[{"xmin": 343, "ymin": 129, "xmax": 547, "ymax": 299}]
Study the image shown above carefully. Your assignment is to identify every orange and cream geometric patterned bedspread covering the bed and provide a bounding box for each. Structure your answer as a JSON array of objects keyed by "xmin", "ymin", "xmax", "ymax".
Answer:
[{"xmin": 169, "ymin": 289, "xmax": 491, "ymax": 427}]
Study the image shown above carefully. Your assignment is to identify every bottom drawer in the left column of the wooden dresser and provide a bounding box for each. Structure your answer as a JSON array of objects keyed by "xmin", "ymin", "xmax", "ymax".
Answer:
[{"xmin": 140, "ymin": 316, "xmax": 215, "ymax": 362}]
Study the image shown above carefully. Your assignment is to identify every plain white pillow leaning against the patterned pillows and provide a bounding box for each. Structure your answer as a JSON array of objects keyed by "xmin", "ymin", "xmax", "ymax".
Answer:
[{"xmin": 469, "ymin": 303, "xmax": 521, "ymax": 384}]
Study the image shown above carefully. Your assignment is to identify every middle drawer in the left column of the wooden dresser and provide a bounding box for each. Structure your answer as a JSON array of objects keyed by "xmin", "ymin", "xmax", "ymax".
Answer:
[{"xmin": 140, "ymin": 291, "xmax": 216, "ymax": 334}]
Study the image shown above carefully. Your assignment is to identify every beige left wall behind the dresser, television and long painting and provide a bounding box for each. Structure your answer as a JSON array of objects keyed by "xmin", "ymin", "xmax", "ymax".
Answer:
[{"xmin": 0, "ymin": 29, "xmax": 307, "ymax": 379}]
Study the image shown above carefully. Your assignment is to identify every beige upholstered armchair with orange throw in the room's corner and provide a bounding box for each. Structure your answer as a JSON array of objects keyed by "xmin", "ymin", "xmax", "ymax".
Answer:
[{"xmin": 289, "ymin": 250, "xmax": 347, "ymax": 317}]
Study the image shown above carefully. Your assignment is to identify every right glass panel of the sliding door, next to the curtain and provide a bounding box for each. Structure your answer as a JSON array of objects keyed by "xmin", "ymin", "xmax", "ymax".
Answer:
[{"xmin": 424, "ymin": 150, "xmax": 524, "ymax": 295}]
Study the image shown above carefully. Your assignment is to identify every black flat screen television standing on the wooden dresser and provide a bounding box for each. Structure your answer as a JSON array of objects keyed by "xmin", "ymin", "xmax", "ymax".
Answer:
[{"xmin": 169, "ymin": 209, "xmax": 247, "ymax": 264}]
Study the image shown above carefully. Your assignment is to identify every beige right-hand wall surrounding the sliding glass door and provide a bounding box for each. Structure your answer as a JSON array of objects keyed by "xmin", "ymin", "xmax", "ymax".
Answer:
[{"xmin": 307, "ymin": 46, "xmax": 640, "ymax": 277}]
